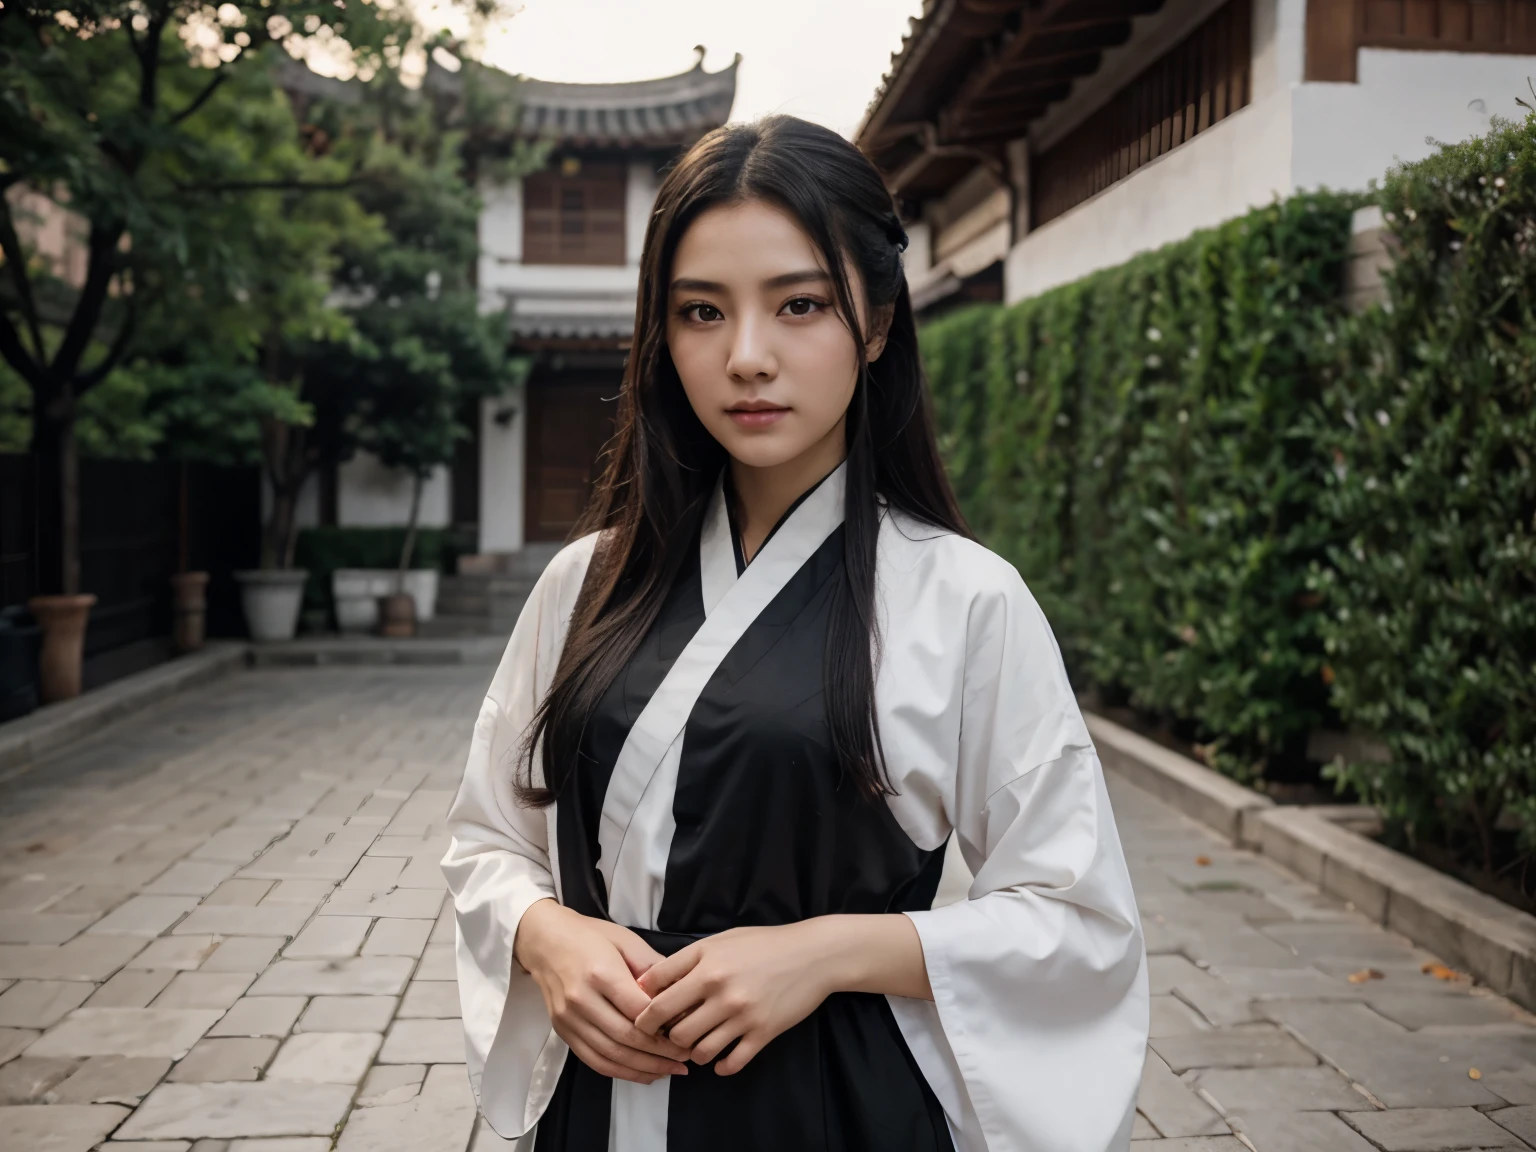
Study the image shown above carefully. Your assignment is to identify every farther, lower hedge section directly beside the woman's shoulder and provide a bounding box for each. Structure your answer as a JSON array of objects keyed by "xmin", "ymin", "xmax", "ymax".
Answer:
[{"xmin": 923, "ymin": 194, "xmax": 1353, "ymax": 776}]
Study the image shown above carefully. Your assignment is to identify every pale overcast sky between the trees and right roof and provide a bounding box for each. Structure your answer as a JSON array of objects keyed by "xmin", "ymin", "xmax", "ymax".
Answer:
[{"xmin": 414, "ymin": 0, "xmax": 923, "ymax": 137}]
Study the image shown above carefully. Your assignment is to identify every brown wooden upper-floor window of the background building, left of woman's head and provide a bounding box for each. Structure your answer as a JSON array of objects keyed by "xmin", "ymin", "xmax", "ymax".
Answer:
[{"xmin": 522, "ymin": 160, "xmax": 625, "ymax": 264}]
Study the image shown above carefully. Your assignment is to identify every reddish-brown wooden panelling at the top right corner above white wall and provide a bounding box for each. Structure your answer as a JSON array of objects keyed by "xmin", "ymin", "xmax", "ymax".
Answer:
[{"xmin": 1307, "ymin": 0, "xmax": 1536, "ymax": 81}]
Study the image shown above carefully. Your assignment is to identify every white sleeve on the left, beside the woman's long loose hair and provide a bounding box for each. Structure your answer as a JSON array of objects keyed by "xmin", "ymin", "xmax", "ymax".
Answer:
[{"xmin": 442, "ymin": 541, "xmax": 591, "ymax": 1138}]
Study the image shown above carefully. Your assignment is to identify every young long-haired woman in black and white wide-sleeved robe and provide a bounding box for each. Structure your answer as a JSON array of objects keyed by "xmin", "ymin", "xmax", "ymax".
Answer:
[{"xmin": 442, "ymin": 117, "xmax": 1147, "ymax": 1152}]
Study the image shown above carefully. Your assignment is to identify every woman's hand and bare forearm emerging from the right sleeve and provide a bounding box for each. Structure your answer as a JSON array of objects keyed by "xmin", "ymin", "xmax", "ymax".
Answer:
[{"xmin": 634, "ymin": 914, "xmax": 934, "ymax": 1075}]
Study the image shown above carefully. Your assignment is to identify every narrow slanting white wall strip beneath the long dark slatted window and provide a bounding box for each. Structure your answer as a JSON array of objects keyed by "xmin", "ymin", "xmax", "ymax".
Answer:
[{"xmin": 1003, "ymin": 91, "xmax": 1292, "ymax": 303}]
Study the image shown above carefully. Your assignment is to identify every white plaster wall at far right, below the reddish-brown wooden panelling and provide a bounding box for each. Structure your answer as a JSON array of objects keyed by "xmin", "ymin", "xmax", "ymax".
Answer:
[{"xmin": 1292, "ymin": 48, "xmax": 1536, "ymax": 189}]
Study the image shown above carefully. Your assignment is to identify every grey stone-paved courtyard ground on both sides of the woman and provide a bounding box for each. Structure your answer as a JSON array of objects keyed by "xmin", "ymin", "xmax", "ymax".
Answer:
[{"xmin": 0, "ymin": 667, "xmax": 1536, "ymax": 1152}]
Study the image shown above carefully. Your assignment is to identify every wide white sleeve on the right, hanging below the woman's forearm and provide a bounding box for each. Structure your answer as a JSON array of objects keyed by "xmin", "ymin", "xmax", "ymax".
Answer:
[{"xmin": 909, "ymin": 565, "xmax": 1147, "ymax": 1152}]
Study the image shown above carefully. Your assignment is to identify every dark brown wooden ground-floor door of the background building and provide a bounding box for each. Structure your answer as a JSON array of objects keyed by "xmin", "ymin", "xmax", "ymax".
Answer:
[{"xmin": 524, "ymin": 373, "xmax": 619, "ymax": 541}]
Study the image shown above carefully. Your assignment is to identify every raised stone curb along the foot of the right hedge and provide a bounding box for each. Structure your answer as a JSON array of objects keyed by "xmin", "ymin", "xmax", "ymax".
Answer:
[{"xmin": 1084, "ymin": 714, "xmax": 1536, "ymax": 1011}]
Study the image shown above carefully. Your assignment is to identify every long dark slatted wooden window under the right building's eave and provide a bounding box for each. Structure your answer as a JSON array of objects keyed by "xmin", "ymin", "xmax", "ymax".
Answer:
[{"xmin": 1029, "ymin": 0, "xmax": 1252, "ymax": 227}]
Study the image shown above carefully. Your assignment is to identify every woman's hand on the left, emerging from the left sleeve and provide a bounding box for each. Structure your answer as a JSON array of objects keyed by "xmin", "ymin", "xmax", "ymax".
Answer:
[{"xmin": 513, "ymin": 900, "xmax": 688, "ymax": 1084}]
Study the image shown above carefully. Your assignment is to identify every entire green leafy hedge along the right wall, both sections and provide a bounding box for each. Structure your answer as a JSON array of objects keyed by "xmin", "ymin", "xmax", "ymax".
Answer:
[{"xmin": 922, "ymin": 110, "xmax": 1536, "ymax": 862}]
